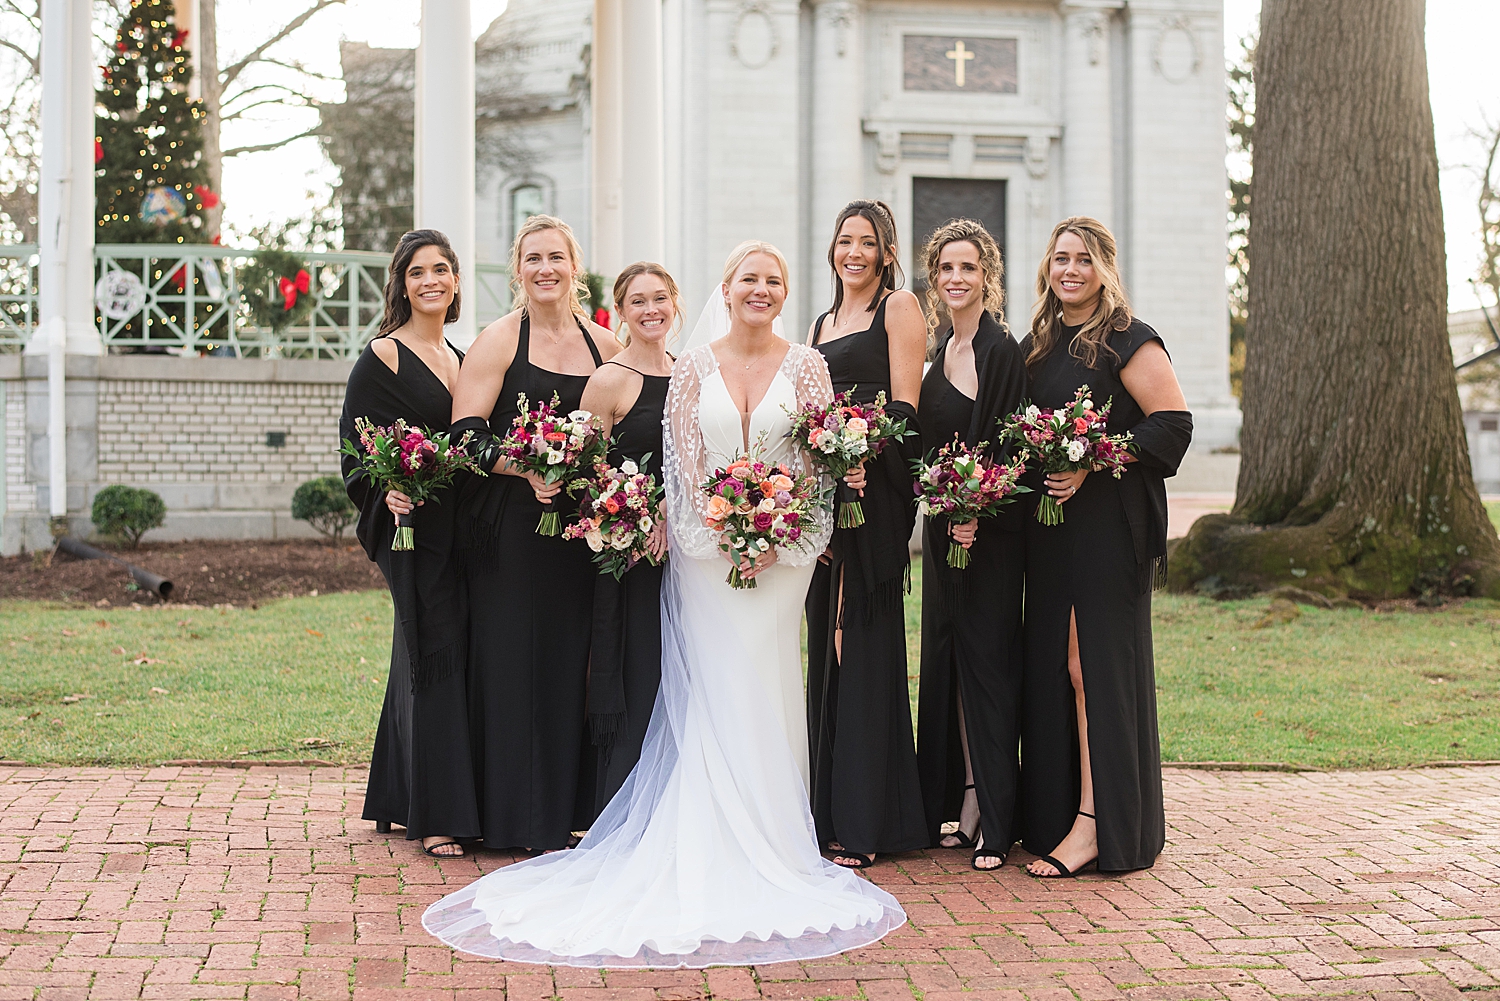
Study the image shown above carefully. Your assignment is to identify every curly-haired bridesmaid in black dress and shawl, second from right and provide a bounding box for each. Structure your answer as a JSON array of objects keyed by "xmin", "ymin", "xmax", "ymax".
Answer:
[{"xmin": 917, "ymin": 219, "xmax": 1026, "ymax": 869}]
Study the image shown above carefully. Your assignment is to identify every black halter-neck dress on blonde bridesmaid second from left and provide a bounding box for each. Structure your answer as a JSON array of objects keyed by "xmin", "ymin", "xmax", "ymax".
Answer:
[{"xmin": 455, "ymin": 318, "xmax": 602, "ymax": 849}]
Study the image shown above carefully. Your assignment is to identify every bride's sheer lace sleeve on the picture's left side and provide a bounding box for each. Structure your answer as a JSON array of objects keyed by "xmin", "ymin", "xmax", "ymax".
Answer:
[{"xmin": 662, "ymin": 345, "xmax": 719, "ymax": 560}]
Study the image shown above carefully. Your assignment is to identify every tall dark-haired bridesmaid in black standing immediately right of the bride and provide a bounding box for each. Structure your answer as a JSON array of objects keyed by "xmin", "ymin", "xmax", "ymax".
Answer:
[{"xmin": 807, "ymin": 200, "xmax": 932, "ymax": 869}]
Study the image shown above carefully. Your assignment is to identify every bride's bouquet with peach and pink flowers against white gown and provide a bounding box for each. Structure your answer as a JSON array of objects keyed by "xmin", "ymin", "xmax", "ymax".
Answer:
[{"xmin": 702, "ymin": 435, "xmax": 819, "ymax": 588}]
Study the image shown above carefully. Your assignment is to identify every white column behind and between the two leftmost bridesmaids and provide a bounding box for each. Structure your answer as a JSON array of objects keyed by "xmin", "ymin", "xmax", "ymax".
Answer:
[{"xmin": 413, "ymin": 0, "xmax": 476, "ymax": 347}]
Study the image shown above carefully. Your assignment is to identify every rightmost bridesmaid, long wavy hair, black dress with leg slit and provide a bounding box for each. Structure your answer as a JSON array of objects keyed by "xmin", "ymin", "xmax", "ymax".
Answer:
[{"xmin": 1022, "ymin": 216, "xmax": 1193, "ymax": 878}]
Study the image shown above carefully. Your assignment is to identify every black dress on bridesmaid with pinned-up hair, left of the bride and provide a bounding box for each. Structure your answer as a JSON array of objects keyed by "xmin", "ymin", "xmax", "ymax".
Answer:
[{"xmin": 588, "ymin": 362, "xmax": 672, "ymax": 815}]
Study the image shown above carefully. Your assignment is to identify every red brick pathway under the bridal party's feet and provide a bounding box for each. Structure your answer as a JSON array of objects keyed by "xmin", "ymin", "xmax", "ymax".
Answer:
[{"xmin": 0, "ymin": 767, "xmax": 1500, "ymax": 1001}]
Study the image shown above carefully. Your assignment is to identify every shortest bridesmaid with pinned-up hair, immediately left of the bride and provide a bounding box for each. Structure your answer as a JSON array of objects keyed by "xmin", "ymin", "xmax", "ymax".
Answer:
[{"xmin": 584, "ymin": 261, "xmax": 681, "ymax": 813}]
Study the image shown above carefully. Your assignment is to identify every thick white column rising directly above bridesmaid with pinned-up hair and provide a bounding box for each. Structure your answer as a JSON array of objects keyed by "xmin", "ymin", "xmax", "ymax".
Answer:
[{"xmin": 621, "ymin": 0, "xmax": 666, "ymax": 265}]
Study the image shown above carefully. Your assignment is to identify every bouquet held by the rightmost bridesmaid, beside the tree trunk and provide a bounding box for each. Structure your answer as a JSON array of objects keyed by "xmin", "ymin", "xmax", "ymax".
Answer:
[{"xmin": 1001, "ymin": 384, "xmax": 1131, "ymax": 525}]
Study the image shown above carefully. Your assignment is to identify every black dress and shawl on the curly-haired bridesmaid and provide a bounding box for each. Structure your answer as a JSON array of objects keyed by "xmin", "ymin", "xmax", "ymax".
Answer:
[{"xmin": 917, "ymin": 314, "xmax": 1026, "ymax": 855}]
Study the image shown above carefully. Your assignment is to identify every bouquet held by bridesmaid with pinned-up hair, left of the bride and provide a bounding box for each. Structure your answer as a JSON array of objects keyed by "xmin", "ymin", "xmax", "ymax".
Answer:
[{"xmin": 563, "ymin": 456, "xmax": 663, "ymax": 581}]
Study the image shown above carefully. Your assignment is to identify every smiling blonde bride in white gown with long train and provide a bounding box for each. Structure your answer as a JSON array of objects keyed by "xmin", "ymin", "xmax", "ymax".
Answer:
[{"xmin": 423, "ymin": 242, "xmax": 906, "ymax": 968}]
